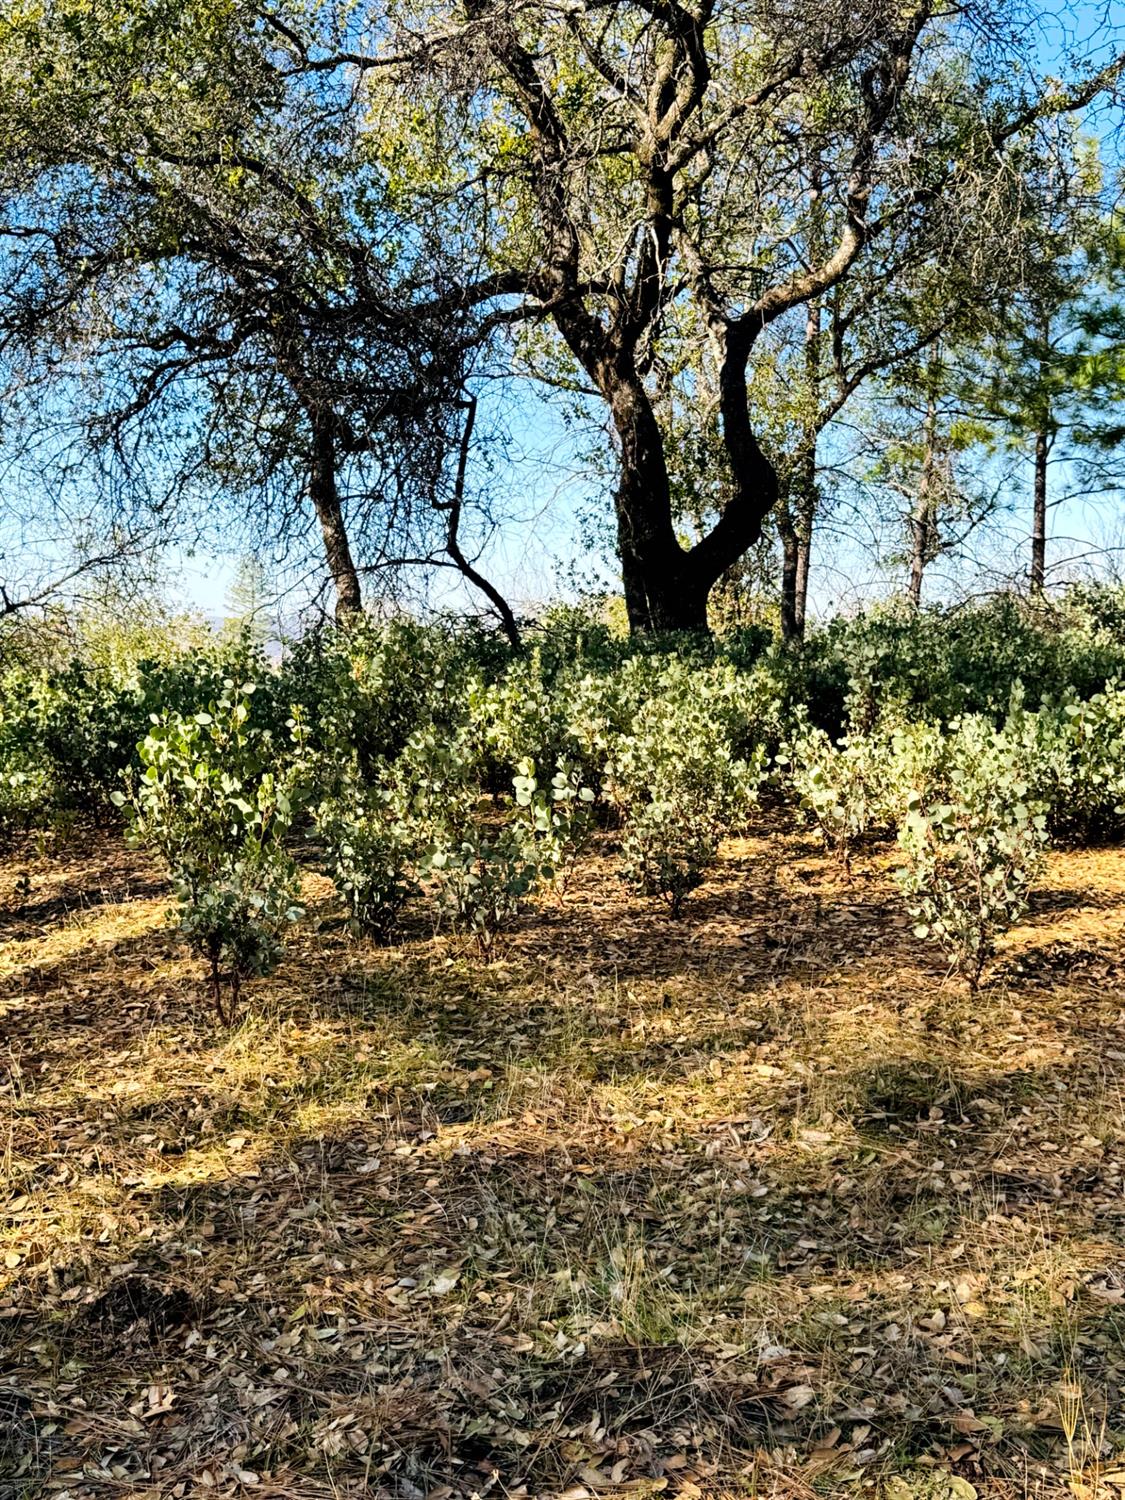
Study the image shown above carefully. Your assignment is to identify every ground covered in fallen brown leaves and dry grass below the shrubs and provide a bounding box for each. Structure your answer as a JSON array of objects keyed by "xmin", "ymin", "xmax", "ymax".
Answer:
[{"xmin": 0, "ymin": 827, "xmax": 1125, "ymax": 1500}]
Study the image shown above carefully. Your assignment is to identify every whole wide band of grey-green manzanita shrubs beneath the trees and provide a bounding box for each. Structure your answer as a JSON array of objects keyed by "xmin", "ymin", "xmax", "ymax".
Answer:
[{"xmin": 13, "ymin": 591, "xmax": 1125, "ymax": 1014}]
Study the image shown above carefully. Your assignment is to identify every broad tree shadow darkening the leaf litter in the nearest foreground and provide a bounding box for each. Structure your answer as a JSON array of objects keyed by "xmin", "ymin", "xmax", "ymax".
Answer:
[{"xmin": 6, "ymin": 1058, "xmax": 1125, "ymax": 1494}]
